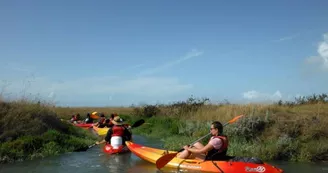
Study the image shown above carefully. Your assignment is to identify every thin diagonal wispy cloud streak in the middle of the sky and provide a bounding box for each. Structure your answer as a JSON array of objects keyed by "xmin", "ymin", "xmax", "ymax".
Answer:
[{"xmin": 139, "ymin": 49, "xmax": 204, "ymax": 75}]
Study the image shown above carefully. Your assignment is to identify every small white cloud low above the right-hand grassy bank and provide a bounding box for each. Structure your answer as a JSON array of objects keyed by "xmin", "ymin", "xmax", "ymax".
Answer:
[{"xmin": 243, "ymin": 90, "xmax": 282, "ymax": 101}]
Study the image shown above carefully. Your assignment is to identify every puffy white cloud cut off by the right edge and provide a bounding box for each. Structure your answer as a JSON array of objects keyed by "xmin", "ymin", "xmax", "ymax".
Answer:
[{"xmin": 305, "ymin": 33, "xmax": 328, "ymax": 70}]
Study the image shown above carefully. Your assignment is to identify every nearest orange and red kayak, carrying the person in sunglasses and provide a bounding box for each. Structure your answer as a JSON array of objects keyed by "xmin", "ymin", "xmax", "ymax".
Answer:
[{"xmin": 126, "ymin": 141, "xmax": 283, "ymax": 173}]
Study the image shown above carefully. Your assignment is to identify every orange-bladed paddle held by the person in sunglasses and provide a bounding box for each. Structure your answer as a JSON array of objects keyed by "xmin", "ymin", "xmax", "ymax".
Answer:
[{"xmin": 156, "ymin": 115, "xmax": 244, "ymax": 169}]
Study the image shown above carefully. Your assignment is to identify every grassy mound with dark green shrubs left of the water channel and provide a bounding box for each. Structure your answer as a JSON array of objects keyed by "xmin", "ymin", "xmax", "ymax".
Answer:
[{"xmin": 0, "ymin": 100, "xmax": 96, "ymax": 163}]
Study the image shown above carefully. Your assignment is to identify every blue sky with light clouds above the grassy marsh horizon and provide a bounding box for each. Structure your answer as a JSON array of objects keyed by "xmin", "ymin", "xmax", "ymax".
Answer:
[{"xmin": 0, "ymin": 0, "xmax": 328, "ymax": 106}]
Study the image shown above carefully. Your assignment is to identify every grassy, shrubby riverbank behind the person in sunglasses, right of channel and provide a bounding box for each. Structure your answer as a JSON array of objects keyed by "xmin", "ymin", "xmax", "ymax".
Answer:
[{"xmin": 55, "ymin": 94, "xmax": 328, "ymax": 162}]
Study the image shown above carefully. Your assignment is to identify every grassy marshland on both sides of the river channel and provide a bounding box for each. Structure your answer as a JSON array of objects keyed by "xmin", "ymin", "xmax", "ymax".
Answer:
[{"xmin": 0, "ymin": 94, "xmax": 328, "ymax": 162}]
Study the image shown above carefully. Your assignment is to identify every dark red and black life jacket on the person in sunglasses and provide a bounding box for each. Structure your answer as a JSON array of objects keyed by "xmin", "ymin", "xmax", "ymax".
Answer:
[{"xmin": 205, "ymin": 135, "xmax": 229, "ymax": 160}]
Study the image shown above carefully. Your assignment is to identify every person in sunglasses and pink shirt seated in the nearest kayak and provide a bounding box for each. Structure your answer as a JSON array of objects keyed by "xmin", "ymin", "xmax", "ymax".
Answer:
[{"xmin": 177, "ymin": 121, "xmax": 229, "ymax": 160}]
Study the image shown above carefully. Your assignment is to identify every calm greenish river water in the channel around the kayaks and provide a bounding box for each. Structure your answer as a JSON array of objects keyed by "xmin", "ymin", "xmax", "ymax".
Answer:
[{"xmin": 0, "ymin": 135, "xmax": 328, "ymax": 173}]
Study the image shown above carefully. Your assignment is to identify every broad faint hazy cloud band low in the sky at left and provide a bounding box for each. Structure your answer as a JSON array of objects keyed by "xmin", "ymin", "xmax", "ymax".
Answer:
[{"xmin": 0, "ymin": 76, "xmax": 193, "ymax": 102}]
